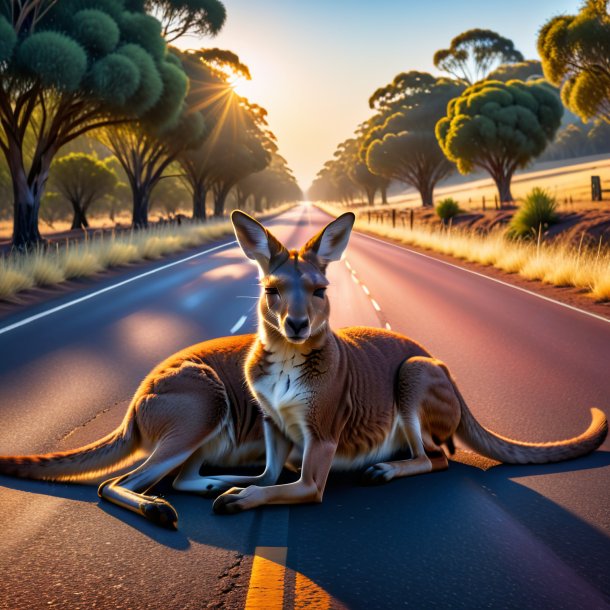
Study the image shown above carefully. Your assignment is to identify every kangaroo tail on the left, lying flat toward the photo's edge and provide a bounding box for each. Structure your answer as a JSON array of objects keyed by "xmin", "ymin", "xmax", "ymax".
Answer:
[{"xmin": 0, "ymin": 412, "xmax": 139, "ymax": 481}]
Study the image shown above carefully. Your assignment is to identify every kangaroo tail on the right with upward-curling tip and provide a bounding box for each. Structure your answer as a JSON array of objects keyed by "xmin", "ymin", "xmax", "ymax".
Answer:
[{"xmin": 454, "ymin": 384, "xmax": 608, "ymax": 464}]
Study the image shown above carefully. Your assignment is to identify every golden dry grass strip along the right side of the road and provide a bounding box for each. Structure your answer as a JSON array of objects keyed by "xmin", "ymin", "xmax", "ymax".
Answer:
[{"xmin": 317, "ymin": 203, "xmax": 610, "ymax": 301}]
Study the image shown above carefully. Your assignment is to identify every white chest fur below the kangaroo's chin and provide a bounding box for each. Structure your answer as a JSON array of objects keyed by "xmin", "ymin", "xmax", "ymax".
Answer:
[{"xmin": 253, "ymin": 347, "xmax": 311, "ymax": 445}]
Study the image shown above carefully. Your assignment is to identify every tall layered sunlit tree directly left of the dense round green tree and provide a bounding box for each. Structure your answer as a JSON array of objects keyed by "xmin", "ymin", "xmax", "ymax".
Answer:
[{"xmin": 364, "ymin": 72, "xmax": 463, "ymax": 206}]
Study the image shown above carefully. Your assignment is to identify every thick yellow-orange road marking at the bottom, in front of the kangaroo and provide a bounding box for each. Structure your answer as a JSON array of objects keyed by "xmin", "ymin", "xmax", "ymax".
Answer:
[{"xmin": 246, "ymin": 546, "xmax": 288, "ymax": 610}]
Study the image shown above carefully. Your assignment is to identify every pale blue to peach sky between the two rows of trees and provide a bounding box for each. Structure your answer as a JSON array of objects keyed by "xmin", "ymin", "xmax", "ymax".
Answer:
[{"xmin": 180, "ymin": 0, "xmax": 581, "ymax": 189}]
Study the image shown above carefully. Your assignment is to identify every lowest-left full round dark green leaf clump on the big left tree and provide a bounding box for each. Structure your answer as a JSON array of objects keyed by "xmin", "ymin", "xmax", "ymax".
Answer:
[{"xmin": 17, "ymin": 31, "xmax": 87, "ymax": 91}]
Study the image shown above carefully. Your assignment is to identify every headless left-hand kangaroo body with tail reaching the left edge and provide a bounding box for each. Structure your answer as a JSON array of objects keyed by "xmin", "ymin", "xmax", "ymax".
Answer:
[{"xmin": 0, "ymin": 335, "xmax": 286, "ymax": 529}]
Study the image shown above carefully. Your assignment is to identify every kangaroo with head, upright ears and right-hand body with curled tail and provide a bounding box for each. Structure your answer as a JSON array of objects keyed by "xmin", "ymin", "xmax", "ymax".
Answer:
[{"xmin": 214, "ymin": 211, "xmax": 608, "ymax": 514}]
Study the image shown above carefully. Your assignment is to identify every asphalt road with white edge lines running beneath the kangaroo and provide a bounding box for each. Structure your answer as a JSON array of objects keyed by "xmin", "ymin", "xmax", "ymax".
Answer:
[{"xmin": 0, "ymin": 206, "xmax": 610, "ymax": 610}]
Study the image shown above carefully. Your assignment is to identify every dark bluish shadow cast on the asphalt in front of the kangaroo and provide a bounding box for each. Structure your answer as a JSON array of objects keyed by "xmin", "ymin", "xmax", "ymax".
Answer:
[{"xmin": 0, "ymin": 451, "xmax": 610, "ymax": 608}]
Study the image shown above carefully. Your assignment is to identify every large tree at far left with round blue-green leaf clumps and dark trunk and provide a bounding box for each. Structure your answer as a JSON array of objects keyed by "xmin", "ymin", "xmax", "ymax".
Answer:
[{"xmin": 0, "ymin": 0, "xmax": 182, "ymax": 249}]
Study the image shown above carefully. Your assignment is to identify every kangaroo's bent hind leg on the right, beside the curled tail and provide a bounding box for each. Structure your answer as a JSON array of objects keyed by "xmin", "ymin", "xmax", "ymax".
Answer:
[{"xmin": 363, "ymin": 357, "xmax": 460, "ymax": 485}]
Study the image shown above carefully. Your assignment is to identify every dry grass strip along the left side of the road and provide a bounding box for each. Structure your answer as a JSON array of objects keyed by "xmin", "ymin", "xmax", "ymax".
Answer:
[{"xmin": 0, "ymin": 204, "xmax": 292, "ymax": 299}]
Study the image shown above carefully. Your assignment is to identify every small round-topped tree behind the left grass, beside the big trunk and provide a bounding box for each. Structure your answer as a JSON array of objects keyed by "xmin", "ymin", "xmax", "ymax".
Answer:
[{"xmin": 50, "ymin": 153, "xmax": 118, "ymax": 229}]
